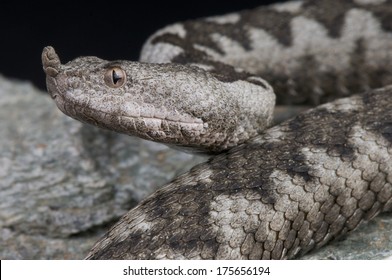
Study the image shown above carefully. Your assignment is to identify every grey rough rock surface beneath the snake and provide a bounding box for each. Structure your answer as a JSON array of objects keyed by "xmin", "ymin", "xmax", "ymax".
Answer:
[{"xmin": 0, "ymin": 76, "xmax": 392, "ymax": 259}]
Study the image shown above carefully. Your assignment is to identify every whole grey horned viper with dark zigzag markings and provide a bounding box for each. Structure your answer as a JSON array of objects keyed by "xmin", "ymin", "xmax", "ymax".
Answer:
[{"xmin": 42, "ymin": 0, "xmax": 392, "ymax": 259}]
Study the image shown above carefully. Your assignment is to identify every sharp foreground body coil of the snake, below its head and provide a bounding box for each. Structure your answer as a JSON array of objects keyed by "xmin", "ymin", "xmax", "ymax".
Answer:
[{"xmin": 84, "ymin": 88, "xmax": 392, "ymax": 259}]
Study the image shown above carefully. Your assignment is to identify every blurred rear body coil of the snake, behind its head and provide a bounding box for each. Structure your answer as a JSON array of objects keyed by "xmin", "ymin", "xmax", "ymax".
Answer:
[{"xmin": 141, "ymin": 0, "xmax": 392, "ymax": 104}]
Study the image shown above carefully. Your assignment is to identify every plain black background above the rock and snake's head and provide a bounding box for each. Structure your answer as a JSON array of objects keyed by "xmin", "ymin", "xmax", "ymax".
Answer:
[{"xmin": 0, "ymin": 0, "xmax": 277, "ymax": 89}]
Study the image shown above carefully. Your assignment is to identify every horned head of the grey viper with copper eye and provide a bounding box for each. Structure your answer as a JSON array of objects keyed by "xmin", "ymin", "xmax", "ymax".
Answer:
[{"xmin": 42, "ymin": 47, "xmax": 274, "ymax": 153}]
